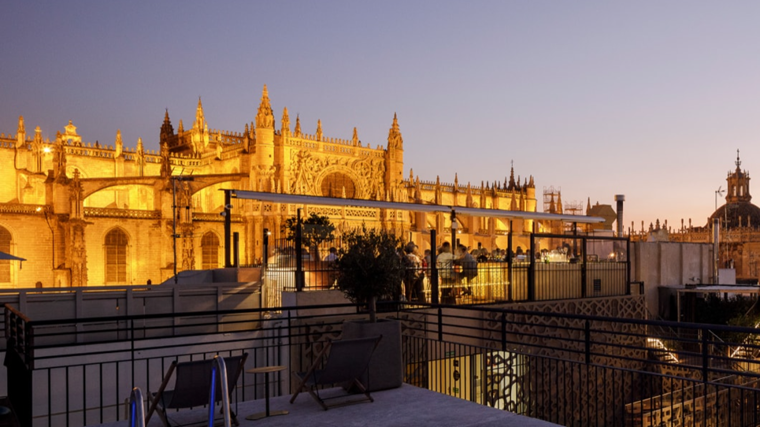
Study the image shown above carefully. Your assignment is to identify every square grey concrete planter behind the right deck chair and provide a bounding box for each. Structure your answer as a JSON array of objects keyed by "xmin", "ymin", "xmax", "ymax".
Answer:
[{"xmin": 343, "ymin": 320, "xmax": 404, "ymax": 391}]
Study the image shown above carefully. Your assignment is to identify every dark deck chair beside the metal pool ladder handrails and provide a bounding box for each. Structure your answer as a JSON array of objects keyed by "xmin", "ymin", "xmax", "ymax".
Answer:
[{"xmin": 145, "ymin": 353, "xmax": 248, "ymax": 427}]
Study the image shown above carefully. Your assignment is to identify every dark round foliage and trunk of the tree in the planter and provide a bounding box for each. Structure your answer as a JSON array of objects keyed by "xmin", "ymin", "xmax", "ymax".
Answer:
[{"xmin": 335, "ymin": 225, "xmax": 404, "ymax": 322}]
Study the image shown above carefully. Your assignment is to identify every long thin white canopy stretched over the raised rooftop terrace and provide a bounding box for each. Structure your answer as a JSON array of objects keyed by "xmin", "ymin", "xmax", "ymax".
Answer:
[{"xmin": 231, "ymin": 190, "xmax": 604, "ymax": 224}]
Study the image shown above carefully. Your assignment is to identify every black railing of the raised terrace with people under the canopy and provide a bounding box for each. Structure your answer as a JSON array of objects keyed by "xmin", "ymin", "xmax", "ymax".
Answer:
[{"xmin": 262, "ymin": 233, "xmax": 631, "ymax": 307}]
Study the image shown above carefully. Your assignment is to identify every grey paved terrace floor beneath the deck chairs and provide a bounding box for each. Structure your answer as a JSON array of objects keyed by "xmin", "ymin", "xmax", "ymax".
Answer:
[{"xmin": 95, "ymin": 384, "xmax": 557, "ymax": 427}]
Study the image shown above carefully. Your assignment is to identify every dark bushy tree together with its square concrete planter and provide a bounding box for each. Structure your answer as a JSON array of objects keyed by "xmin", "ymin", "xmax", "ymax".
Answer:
[{"xmin": 335, "ymin": 225, "xmax": 404, "ymax": 391}]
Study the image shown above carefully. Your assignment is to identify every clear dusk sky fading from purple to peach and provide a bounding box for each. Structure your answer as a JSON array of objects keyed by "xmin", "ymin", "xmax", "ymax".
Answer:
[{"xmin": 0, "ymin": 0, "xmax": 760, "ymax": 234}]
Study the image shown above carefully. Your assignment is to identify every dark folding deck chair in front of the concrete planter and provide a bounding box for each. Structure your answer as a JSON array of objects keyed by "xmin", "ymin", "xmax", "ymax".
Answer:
[{"xmin": 290, "ymin": 335, "xmax": 383, "ymax": 411}]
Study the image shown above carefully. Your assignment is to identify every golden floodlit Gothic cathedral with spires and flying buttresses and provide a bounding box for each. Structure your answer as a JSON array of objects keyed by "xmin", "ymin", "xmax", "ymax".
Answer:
[{"xmin": 0, "ymin": 86, "xmax": 540, "ymax": 288}]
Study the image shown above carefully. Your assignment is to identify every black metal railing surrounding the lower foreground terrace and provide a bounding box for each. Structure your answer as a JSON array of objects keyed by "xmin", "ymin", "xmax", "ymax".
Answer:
[{"xmin": 6, "ymin": 296, "xmax": 760, "ymax": 426}]
